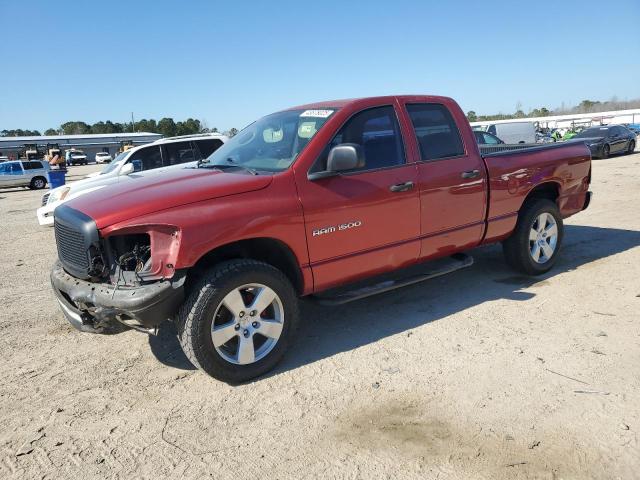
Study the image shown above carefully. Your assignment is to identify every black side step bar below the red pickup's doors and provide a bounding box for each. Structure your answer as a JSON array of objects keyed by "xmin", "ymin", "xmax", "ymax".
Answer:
[{"xmin": 312, "ymin": 253, "xmax": 473, "ymax": 306}]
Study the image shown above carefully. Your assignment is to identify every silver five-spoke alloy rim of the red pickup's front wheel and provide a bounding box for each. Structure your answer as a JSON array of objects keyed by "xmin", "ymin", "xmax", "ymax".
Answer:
[{"xmin": 211, "ymin": 283, "xmax": 284, "ymax": 365}]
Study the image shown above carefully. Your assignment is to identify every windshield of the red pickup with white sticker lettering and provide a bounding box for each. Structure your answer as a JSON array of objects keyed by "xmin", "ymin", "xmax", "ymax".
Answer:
[{"xmin": 200, "ymin": 108, "xmax": 336, "ymax": 172}]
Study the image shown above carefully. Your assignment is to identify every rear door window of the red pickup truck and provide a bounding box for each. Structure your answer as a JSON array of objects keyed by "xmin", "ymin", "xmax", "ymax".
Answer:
[{"xmin": 407, "ymin": 103, "xmax": 464, "ymax": 160}]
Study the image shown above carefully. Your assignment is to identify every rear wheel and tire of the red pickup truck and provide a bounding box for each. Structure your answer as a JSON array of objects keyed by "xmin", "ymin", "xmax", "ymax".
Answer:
[{"xmin": 502, "ymin": 198, "xmax": 564, "ymax": 275}]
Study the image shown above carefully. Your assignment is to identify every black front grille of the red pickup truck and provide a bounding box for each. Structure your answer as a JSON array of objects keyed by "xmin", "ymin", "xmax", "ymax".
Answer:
[{"xmin": 53, "ymin": 205, "xmax": 102, "ymax": 280}]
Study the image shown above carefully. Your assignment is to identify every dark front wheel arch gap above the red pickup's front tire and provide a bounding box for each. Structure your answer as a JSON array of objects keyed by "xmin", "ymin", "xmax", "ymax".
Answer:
[{"xmin": 187, "ymin": 237, "xmax": 304, "ymax": 295}]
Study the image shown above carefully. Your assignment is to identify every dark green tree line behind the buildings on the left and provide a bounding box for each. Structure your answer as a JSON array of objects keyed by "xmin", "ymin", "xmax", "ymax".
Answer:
[{"xmin": 0, "ymin": 117, "xmax": 238, "ymax": 137}]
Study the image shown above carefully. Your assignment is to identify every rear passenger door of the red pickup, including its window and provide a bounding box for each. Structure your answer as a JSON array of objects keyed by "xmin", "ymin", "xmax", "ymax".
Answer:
[{"xmin": 405, "ymin": 102, "xmax": 487, "ymax": 259}]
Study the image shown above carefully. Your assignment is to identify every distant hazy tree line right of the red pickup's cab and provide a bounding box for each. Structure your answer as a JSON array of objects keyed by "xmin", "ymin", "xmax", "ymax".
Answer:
[{"xmin": 467, "ymin": 97, "xmax": 640, "ymax": 122}]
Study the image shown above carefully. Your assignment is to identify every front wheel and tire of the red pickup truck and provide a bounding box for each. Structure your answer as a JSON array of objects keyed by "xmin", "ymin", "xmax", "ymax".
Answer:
[{"xmin": 178, "ymin": 260, "xmax": 299, "ymax": 384}]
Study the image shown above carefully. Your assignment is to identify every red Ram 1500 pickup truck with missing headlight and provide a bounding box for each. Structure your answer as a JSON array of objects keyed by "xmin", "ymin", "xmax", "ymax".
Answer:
[{"xmin": 51, "ymin": 95, "xmax": 591, "ymax": 383}]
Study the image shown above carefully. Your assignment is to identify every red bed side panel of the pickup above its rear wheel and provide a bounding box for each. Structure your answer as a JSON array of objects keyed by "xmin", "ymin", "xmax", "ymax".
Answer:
[{"xmin": 484, "ymin": 142, "xmax": 591, "ymax": 243}]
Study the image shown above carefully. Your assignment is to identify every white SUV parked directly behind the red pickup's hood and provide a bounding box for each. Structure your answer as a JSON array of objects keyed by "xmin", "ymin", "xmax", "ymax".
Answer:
[{"xmin": 37, "ymin": 133, "xmax": 229, "ymax": 225}]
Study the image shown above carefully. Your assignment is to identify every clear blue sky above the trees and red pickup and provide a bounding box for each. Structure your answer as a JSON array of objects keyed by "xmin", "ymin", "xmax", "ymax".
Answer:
[{"xmin": 0, "ymin": 0, "xmax": 640, "ymax": 130}]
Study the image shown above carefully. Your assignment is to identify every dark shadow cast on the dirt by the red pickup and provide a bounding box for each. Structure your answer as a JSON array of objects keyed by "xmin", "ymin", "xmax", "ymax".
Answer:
[{"xmin": 149, "ymin": 225, "xmax": 640, "ymax": 381}]
